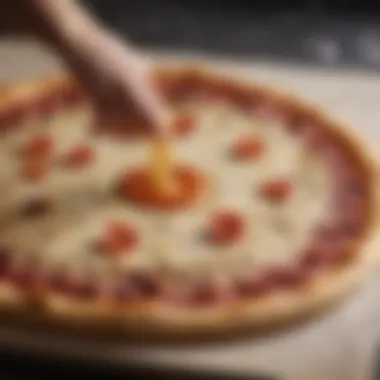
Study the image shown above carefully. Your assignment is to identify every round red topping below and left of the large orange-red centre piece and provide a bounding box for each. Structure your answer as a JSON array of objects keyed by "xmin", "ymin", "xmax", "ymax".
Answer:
[{"xmin": 99, "ymin": 222, "xmax": 138, "ymax": 256}]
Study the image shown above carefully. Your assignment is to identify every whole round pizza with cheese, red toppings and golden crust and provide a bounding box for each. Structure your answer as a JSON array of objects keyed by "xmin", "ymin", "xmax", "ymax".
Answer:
[{"xmin": 0, "ymin": 66, "xmax": 378, "ymax": 339}]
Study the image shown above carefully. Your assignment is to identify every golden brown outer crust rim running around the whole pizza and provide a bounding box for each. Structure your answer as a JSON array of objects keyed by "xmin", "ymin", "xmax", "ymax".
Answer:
[{"xmin": 0, "ymin": 66, "xmax": 379, "ymax": 340}]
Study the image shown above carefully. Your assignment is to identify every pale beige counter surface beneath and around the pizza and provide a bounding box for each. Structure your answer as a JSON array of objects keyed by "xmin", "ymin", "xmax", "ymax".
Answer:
[{"xmin": 0, "ymin": 40, "xmax": 380, "ymax": 380}]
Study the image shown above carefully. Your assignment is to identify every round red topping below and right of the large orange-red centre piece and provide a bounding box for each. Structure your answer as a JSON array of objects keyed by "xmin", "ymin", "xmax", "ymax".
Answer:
[{"xmin": 207, "ymin": 211, "xmax": 245, "ymax": 245}]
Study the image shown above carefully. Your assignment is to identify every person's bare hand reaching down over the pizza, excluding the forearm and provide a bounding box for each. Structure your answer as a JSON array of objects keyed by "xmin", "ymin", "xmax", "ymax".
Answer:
[{"xmin": 62, "ymin": 29, "xmax": 168, "ymax": 137}]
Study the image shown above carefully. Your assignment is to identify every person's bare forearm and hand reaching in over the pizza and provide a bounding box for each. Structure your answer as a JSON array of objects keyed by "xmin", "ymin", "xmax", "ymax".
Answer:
[{"xmin": 0, "ymin": 0, "xmax": 166, "ymax": 137}]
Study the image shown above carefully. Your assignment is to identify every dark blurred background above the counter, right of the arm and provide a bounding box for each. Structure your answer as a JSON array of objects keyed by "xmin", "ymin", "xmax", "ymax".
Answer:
[{"xmin": 77, "ymin": 0, "xmax": 380, "ymax": 70}]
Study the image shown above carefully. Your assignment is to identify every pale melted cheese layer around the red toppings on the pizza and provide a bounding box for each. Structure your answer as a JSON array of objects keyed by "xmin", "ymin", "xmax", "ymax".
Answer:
[{"xmin": 0, "ymin": 99, "xmax": 329, "ymax": 282}]
